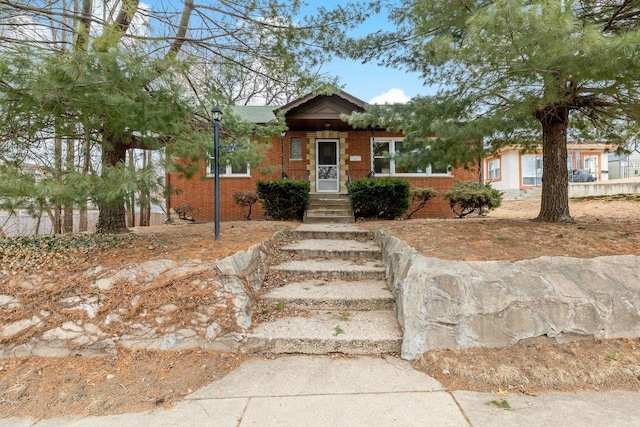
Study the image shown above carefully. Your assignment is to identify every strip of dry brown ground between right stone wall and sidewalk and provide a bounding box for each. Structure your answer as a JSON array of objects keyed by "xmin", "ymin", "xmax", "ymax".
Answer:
[{"xmin": 414, "ymin": 339, "xmax": 640, "ymax": 394}]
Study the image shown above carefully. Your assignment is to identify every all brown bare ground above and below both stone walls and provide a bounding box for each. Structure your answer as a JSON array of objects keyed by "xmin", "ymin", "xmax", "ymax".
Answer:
[{"xmin": 0, "ymin": 198, "xmax": 640, "ymax": 418}]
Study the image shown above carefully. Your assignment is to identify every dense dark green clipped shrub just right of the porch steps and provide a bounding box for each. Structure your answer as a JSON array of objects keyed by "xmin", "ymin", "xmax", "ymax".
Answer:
[{"xmin": 347, "ymin": 178, "xmax": 409, "ymax": 219}]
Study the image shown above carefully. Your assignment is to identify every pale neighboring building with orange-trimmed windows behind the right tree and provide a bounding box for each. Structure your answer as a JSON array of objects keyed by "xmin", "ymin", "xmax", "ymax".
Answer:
[{"xmin": 483, "ymin": 141, "xmax": 610, "ymax": 198}]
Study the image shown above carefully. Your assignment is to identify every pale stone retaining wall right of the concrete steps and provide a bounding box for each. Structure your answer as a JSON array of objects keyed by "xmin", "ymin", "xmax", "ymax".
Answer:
[{"xmin": 376, "ymin": 231, "xmax": 640, "ymax": 359}]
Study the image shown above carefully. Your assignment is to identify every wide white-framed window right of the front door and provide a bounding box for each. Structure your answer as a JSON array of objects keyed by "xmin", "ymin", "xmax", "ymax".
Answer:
[{"xmin": 371, "ymin": 138, "xmax": 451, "ymax": 176}]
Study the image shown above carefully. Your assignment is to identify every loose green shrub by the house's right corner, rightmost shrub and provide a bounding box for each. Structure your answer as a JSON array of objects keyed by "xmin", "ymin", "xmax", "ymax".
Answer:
[{"xmin": 443, "ymin": 180, "xmax": 502, "ymax": 218}]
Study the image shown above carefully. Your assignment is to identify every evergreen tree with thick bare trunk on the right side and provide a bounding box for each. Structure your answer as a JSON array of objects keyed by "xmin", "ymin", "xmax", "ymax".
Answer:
[{"xmin": 340, "ymin": 0, "xmax": 640, "ymax": 222}]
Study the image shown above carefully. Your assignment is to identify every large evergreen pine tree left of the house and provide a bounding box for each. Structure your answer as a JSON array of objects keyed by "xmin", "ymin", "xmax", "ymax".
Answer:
[{"xmin": 0, "ymin": 0, "xmax": 372, "ymax": 232}]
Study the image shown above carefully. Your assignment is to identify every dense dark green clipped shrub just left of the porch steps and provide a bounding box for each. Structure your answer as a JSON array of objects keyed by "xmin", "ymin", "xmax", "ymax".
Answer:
[{"xmin": 257, "ymin": 179, "xmax": 310, "ymax": 220}]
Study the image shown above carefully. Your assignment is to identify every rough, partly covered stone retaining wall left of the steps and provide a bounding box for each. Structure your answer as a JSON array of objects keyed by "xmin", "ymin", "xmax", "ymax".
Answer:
[{"xmin": 0, "ymin": 233, "xmax": 281, "ymax": 358}]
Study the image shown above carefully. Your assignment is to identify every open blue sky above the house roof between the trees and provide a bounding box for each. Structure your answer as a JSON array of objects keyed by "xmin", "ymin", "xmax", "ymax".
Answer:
[{"xmin": 307, "ymin": 0, "xmax": 433, "ymax": 104}]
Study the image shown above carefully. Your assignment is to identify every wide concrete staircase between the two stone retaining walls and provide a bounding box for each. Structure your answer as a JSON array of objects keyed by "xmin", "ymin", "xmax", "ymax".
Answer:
[{"xmin": 243, "ymin": 225, "xmax": 402, "ymax": 354}]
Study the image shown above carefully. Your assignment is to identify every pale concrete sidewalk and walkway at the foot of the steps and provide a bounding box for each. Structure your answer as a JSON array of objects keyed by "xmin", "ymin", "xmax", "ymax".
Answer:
[{"xmin": 5, "ymin": 356, "xmax": 640, "ymax": 427}]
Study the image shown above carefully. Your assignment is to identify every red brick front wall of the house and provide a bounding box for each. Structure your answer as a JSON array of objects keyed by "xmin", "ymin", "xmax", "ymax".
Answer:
[{"xmin": 168, "ymin": 131, "xmax": 477, "ymax": 222}]
